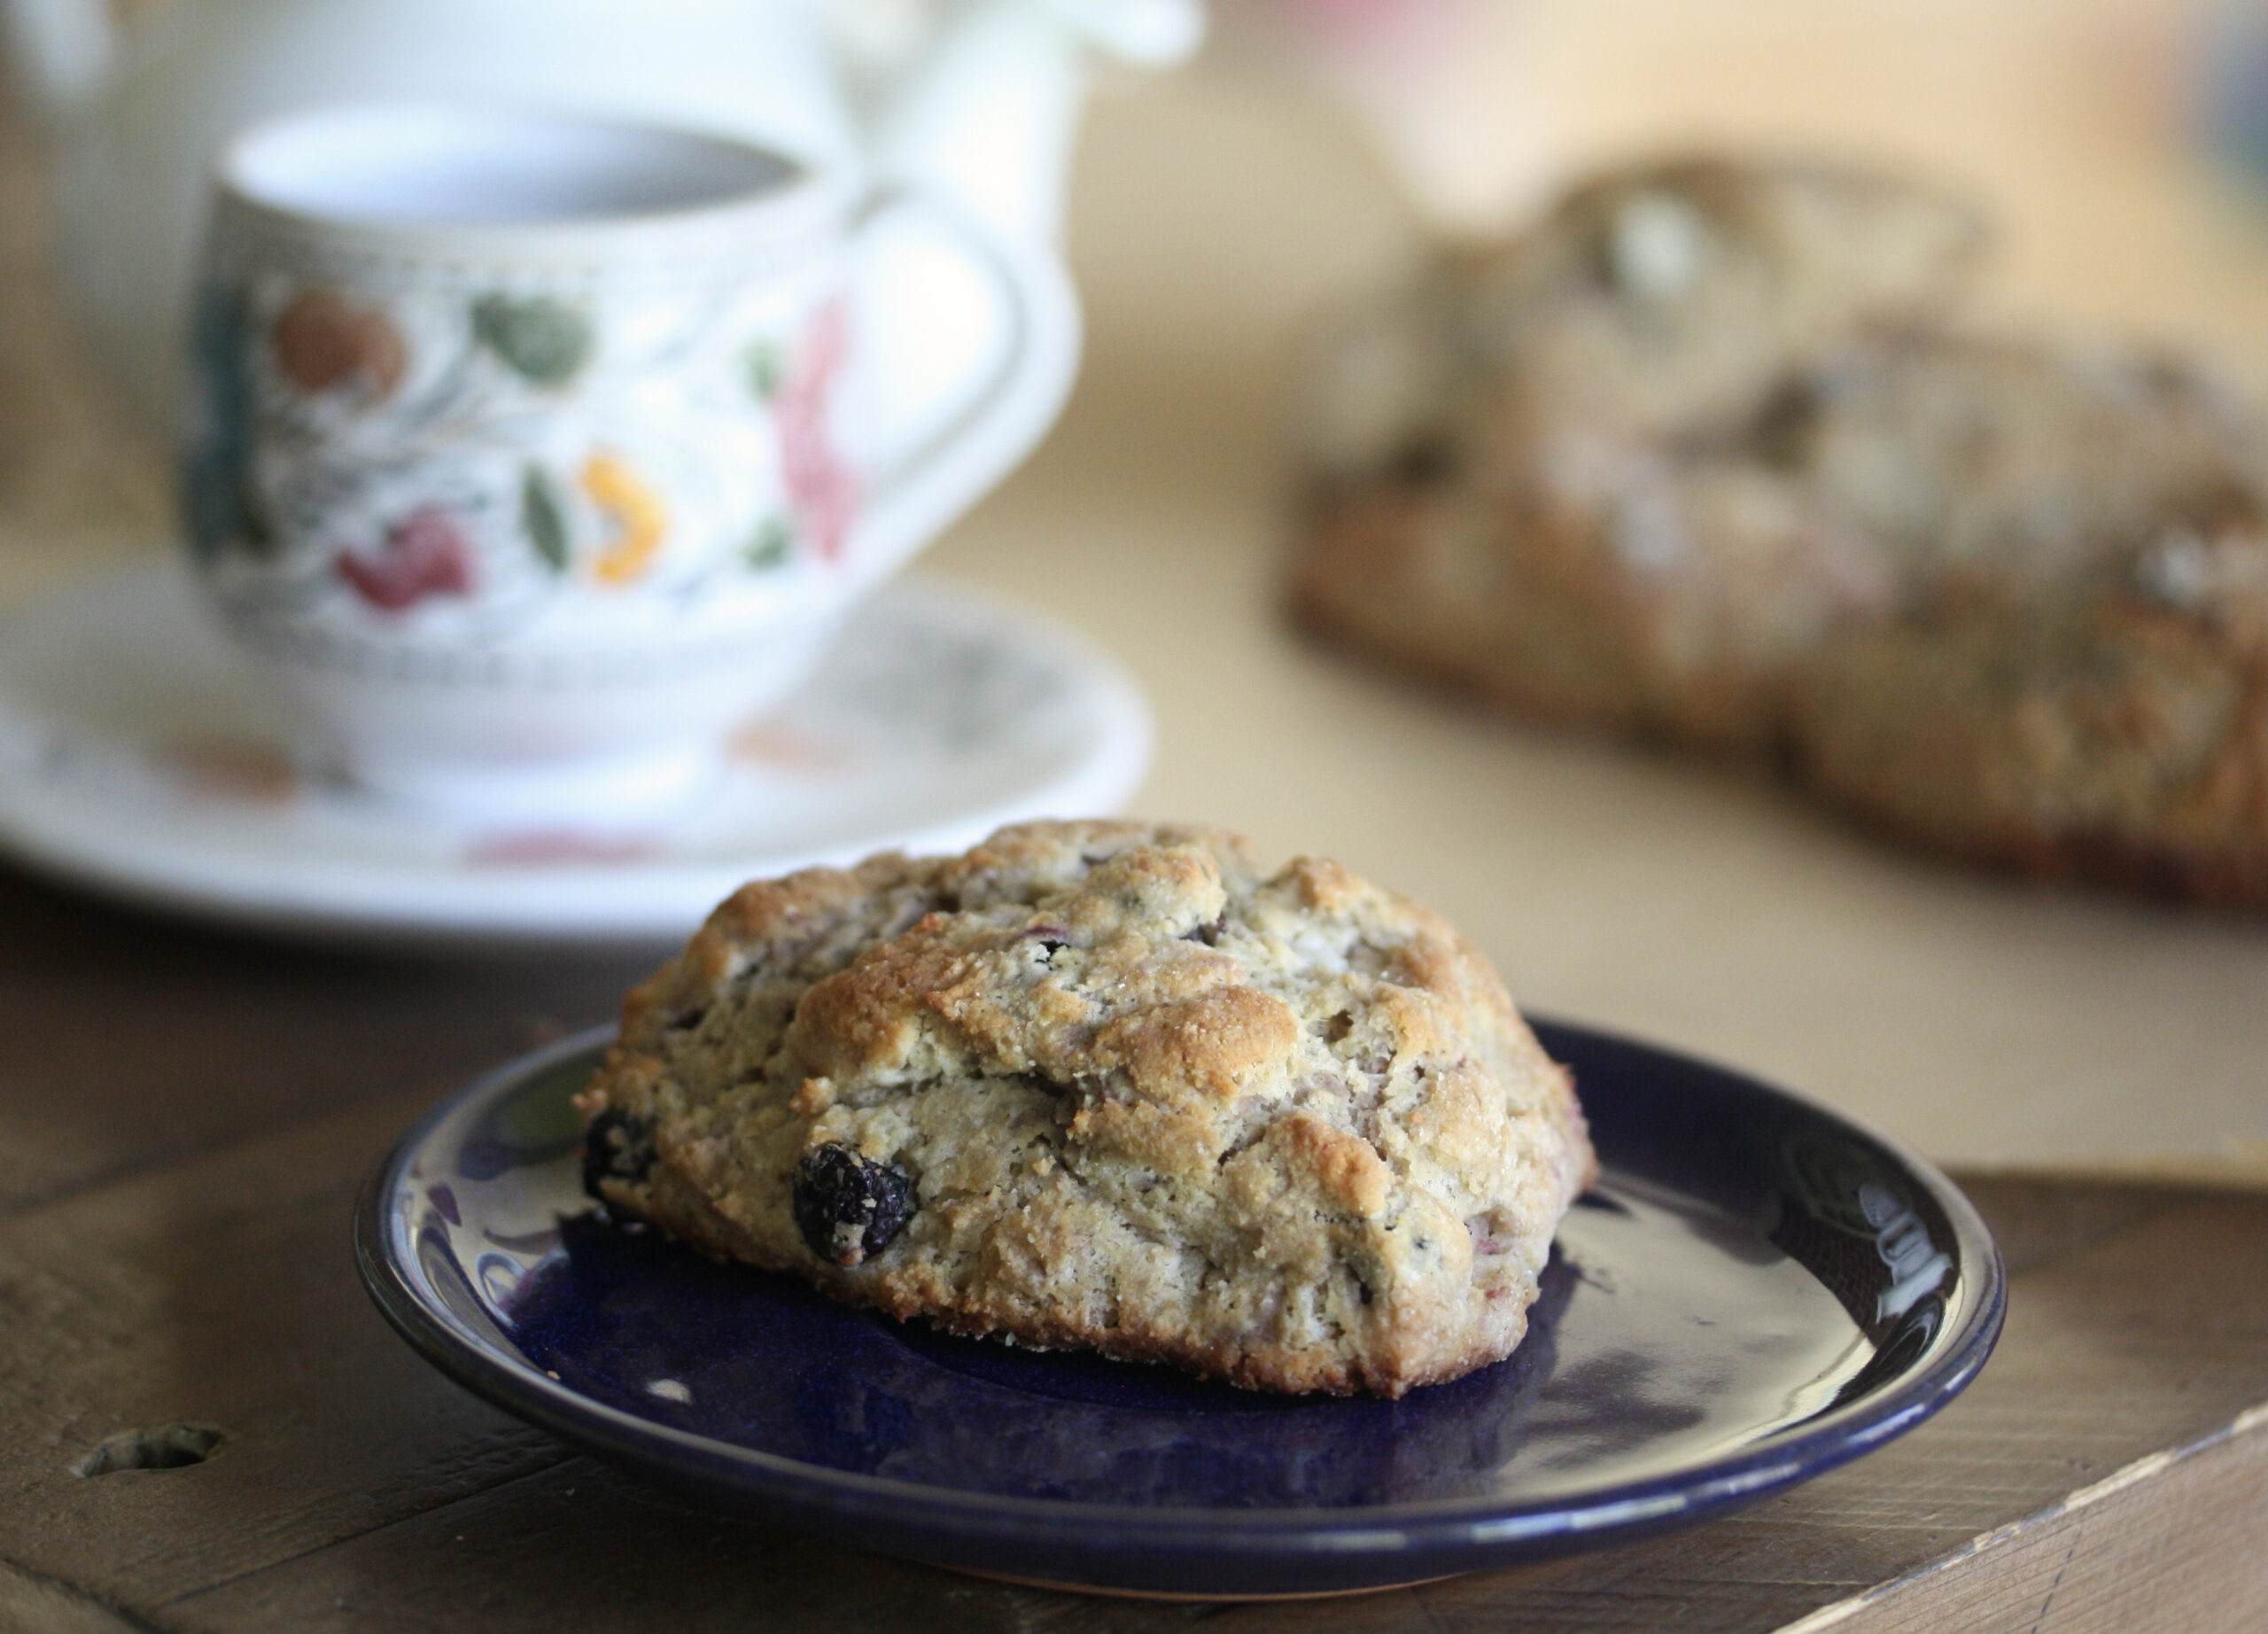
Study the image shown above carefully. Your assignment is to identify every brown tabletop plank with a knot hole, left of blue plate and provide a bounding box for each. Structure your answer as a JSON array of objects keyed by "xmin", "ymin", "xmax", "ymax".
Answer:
[{"xmin": 0, "ymin": 1093, "xmax": 570, "ymax": 1616}]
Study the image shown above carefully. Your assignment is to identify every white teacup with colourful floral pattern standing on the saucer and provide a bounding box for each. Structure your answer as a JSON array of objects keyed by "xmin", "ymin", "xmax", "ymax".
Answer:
[{"xmin": 183, "ymin": 105, "xmax": 1077, "ymax": 821}]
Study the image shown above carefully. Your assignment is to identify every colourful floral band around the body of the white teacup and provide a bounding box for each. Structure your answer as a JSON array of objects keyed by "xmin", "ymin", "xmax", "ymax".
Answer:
[{"xmin": 183, "ymin": 255, "xmax": 859, "ymax": 640}]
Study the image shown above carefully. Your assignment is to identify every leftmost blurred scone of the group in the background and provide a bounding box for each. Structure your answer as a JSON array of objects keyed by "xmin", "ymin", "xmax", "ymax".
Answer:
[{"xmin": 1293, "ymin": 159, "xmax": 1982, "ymax": 751}]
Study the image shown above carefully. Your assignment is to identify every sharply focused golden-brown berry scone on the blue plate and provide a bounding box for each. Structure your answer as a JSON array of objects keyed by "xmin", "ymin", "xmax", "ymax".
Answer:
[{"xmin": 576, "ymin": 821, "xmax": 1595, "ymax": 1396}]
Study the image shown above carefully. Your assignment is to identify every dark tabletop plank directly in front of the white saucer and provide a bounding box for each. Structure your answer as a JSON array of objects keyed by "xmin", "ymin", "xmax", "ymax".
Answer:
[{"xmin": 0, "ymin": 865, "xmax": 649, "ymax": 1214}]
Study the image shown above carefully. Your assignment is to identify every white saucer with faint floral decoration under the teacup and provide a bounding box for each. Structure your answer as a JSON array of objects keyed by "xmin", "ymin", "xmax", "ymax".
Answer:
[{"xmin": 0, "ymin": 563, "xmax": 1150, "ymax": 946}]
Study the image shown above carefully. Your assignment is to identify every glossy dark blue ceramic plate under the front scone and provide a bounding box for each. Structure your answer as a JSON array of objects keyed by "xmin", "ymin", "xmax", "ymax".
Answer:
[{"xmin": 356, "ymin": 1026, "xmax": 2005, "ymax": 1595}]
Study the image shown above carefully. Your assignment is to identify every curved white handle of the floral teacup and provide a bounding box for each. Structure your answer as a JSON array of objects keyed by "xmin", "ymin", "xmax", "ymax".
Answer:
[{"xmin": 843, "ymin": 189, "xmax": 1080, "ymax": 583}]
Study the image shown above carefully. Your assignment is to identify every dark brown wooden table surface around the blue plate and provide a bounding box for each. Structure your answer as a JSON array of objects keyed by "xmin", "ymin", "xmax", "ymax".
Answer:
[{"xmin": 0, "ymin": 848, "xmax": 2268, "ymax": 1634}]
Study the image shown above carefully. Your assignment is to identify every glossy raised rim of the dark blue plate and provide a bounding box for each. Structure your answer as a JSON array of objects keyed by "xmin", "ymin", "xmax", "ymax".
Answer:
[{"xmin": 353, "ymin": 1015, "xmax": 2008, "ymax": 1584}]
